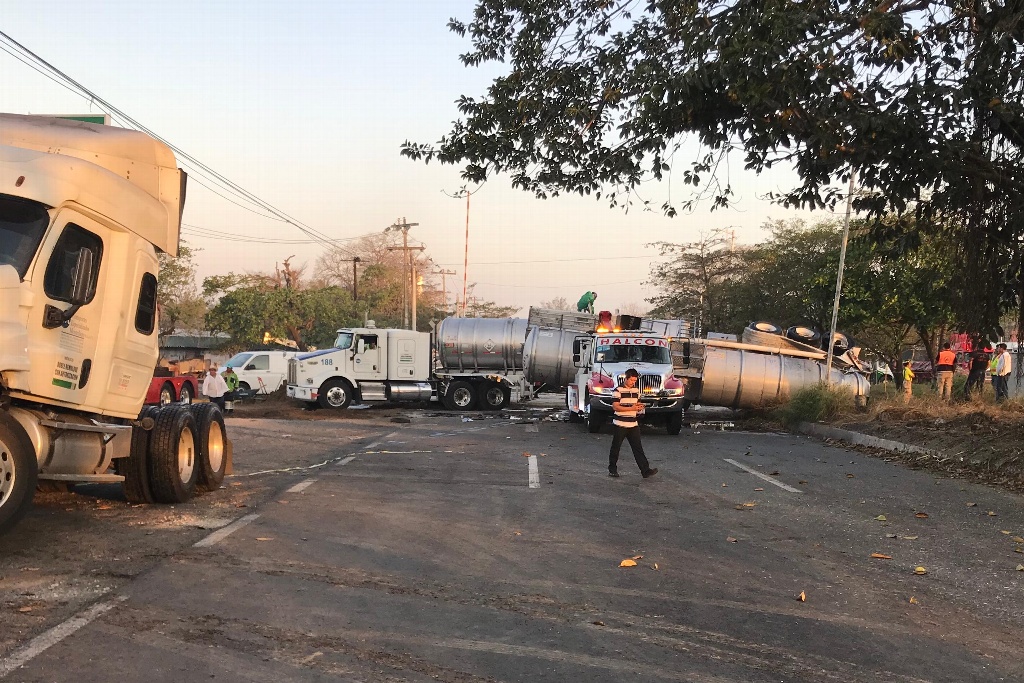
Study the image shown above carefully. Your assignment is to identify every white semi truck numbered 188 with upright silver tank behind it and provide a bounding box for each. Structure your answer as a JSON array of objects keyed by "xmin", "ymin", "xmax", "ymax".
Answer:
[{"xmin": 287, "ymin": 317, "xmax": 534, "ymax": 411}]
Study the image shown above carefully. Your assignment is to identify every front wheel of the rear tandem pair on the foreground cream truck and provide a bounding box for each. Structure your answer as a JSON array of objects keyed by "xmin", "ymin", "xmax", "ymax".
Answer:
[{"xmin": 150, "ymin": 405, "xmax": 199, "ymax": 503}]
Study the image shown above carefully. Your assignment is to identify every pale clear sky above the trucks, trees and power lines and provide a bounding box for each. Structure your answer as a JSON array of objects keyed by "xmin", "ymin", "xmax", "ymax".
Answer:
[{"xmin": 0, "ymin": 0, "xmax": 831, "ymax": 314}]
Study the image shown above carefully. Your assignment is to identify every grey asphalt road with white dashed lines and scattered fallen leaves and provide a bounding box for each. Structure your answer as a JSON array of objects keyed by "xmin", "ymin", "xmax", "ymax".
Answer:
[{"xmin": 0, "ymin": 401, "xmax": 1024, "ymax": 683}]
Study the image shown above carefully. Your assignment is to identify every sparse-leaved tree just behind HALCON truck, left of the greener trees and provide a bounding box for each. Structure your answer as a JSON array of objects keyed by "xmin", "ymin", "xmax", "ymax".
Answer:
[{"xmin": 648, "ymin": 230, "xmax": 744, "ymax": 331}]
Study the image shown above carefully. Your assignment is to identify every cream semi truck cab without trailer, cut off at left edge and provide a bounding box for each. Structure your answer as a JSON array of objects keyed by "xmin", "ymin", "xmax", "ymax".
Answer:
[{"xmin": 0, "ymin": 114, "xmax": 230, "ymax": 532}]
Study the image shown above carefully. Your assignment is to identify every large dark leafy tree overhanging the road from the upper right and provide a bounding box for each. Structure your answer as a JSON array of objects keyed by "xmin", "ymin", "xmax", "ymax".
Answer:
[{"xmin": 401, "ymin": 0, "xmax": 1024, "ymax": 330}]
